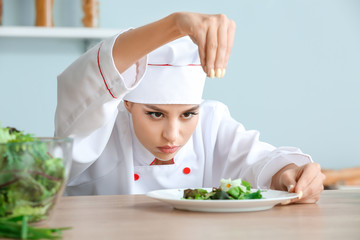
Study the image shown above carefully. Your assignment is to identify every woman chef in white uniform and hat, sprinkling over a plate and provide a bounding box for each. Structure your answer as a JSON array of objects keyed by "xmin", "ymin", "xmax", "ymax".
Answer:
[{"xmin": 55, "ymin": 12, "xmax": 324, "ymax": 203}]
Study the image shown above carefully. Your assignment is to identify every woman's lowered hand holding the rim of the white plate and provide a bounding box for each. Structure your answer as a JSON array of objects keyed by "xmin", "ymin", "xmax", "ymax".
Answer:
[{"xmin": 270, "ymin": 163, "xmax": 325, "ymax": 204}]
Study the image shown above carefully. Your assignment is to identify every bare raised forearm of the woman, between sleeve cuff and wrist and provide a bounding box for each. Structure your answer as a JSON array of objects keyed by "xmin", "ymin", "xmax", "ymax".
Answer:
[{"xmin": 113, "ymin": 13, "xmax": 183, "ymax": 73}]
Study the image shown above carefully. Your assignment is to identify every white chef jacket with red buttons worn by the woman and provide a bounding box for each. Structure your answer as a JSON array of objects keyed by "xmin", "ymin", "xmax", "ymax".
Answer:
[{"xmin": 55, "ymin": 30, "xmax": 312, "ymax": 195}]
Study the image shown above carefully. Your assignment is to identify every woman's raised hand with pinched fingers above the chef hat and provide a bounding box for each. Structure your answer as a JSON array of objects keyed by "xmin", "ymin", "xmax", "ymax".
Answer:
[{"xmin": 176, "ymin": 12, "xmax": 236, "ymax": 78}]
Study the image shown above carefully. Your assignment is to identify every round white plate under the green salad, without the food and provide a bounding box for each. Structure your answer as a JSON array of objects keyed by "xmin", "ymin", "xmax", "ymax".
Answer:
[{"xmin": 146, "ymin": 188, "xmax": 299, "ymax": 212}]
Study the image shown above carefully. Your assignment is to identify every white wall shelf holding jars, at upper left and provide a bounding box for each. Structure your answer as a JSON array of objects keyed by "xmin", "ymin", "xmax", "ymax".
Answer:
[{"xmin": 0, "ymin": 26, "xmax": 120, "ymax": 39}]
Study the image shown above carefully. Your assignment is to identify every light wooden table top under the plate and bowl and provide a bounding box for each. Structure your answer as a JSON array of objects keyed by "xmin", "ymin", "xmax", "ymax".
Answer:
[{"xmin": 47, "ymin": 190, "xmax": 360, "ymax": 240}]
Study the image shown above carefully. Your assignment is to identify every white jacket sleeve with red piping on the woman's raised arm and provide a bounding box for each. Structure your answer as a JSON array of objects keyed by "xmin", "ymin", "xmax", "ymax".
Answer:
[{"xmin": 55, "ymin": 29, "xmax": 147, "ymax": 174}]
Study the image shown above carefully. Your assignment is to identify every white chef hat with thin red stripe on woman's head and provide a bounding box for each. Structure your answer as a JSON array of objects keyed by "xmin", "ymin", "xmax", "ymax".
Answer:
[{"xmin": 124, "ymin": 37, "xmax": 206, "ymax": 104}]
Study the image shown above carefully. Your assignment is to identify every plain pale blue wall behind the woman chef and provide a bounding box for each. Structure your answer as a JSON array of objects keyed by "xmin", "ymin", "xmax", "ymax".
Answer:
[{"xmin": 0, "ymin": 0, "xmax": 360, "ymax": 168}]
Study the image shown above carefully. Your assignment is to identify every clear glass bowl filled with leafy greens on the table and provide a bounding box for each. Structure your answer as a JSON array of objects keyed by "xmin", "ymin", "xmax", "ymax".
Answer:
[{"xmin": 0, "ymin": 138, "xmax": 73, "ymax": 222}]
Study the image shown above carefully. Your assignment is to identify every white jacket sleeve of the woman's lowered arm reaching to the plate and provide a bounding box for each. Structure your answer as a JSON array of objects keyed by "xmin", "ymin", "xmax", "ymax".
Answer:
[{"xmin": 208, "ymin": 100, "xmax": 312, "ymax": 189}]
